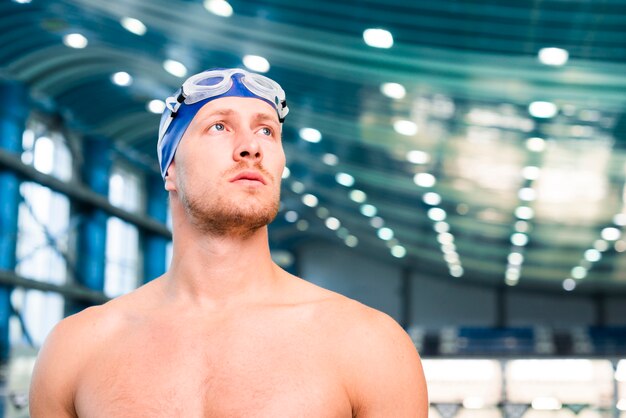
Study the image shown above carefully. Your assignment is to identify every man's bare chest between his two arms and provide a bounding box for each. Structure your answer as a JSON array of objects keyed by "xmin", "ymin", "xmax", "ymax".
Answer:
[{"xmin": 75, "ymin": 318, "xmax": 352, "ymax": 418}]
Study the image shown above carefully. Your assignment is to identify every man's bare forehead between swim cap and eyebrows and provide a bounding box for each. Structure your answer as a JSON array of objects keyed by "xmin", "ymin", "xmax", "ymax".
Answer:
[{"xmin": 194, "ymin": 97, "xmax": 278, "ymax": 123}]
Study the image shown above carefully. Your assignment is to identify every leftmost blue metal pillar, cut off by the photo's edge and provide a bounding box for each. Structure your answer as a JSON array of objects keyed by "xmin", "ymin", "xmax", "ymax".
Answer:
[{"xmin": 0, "ymin": 82, "xmax": 28, "ymax": 417}]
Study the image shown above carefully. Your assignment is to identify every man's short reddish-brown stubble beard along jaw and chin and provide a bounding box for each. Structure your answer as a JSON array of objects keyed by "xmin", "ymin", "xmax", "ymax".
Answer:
[{"xmin": 178, "ymin": 165, "xmax": 280, "ymax": 238}]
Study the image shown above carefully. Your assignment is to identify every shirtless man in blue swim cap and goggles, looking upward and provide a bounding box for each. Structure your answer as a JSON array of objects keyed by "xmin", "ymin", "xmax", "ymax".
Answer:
[{"xmin": 30, "ymin": 69, "xmax": 428, "ymax": 418}]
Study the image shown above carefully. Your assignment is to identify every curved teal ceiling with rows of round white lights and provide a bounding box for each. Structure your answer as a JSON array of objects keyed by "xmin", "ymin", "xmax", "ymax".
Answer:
[{"xmin": 0, "ymin": 0, "xmax": 626, "ymax": 292}]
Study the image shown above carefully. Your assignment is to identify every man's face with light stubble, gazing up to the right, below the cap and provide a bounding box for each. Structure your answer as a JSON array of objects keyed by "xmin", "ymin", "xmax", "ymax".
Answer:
[{"xmin": 166, "ymin": 97, "xmax": 285, "ymax": 235}]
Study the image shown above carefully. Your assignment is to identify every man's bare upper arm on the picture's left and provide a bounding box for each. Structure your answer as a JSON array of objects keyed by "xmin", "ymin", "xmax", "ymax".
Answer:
[{"xmin": 29, "ymin": 318, "xmax": 81, "ymax": 418}]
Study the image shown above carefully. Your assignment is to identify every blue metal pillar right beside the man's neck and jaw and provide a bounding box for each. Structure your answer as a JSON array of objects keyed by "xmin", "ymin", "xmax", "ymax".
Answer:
[{"xmin": 143, "ymin": 171, "xmax": 168, "ymax": 283}]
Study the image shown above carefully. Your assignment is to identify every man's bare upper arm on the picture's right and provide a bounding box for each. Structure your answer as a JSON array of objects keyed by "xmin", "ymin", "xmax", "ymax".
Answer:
[{"xmin": 349, "ymin": 311, "xmax": 428, "ymax": 418}]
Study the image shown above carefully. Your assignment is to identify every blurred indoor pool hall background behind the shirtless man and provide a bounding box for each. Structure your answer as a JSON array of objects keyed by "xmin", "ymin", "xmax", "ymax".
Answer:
[{"xmin": 0, "ymin": 0, "xmax": 626, "ymax": 418}]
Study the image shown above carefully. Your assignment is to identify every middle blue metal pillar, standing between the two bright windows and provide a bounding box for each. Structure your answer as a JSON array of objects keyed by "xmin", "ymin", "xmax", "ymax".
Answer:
[{"xmin": 65, "ymin": 138, "xmax": 112, "ymax": 315}]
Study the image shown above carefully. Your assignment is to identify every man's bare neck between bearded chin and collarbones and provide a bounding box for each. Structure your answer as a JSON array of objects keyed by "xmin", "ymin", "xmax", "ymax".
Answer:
[{"xmin": 165, "ymin": 214, "xmax": 280, "ymax": 308}]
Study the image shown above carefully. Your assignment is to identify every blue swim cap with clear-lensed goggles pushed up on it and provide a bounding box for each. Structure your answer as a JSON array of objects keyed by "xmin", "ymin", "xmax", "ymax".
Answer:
[{"xmin": 157, "ymin": 68, "xmax": 289, "ymax": 178}]
